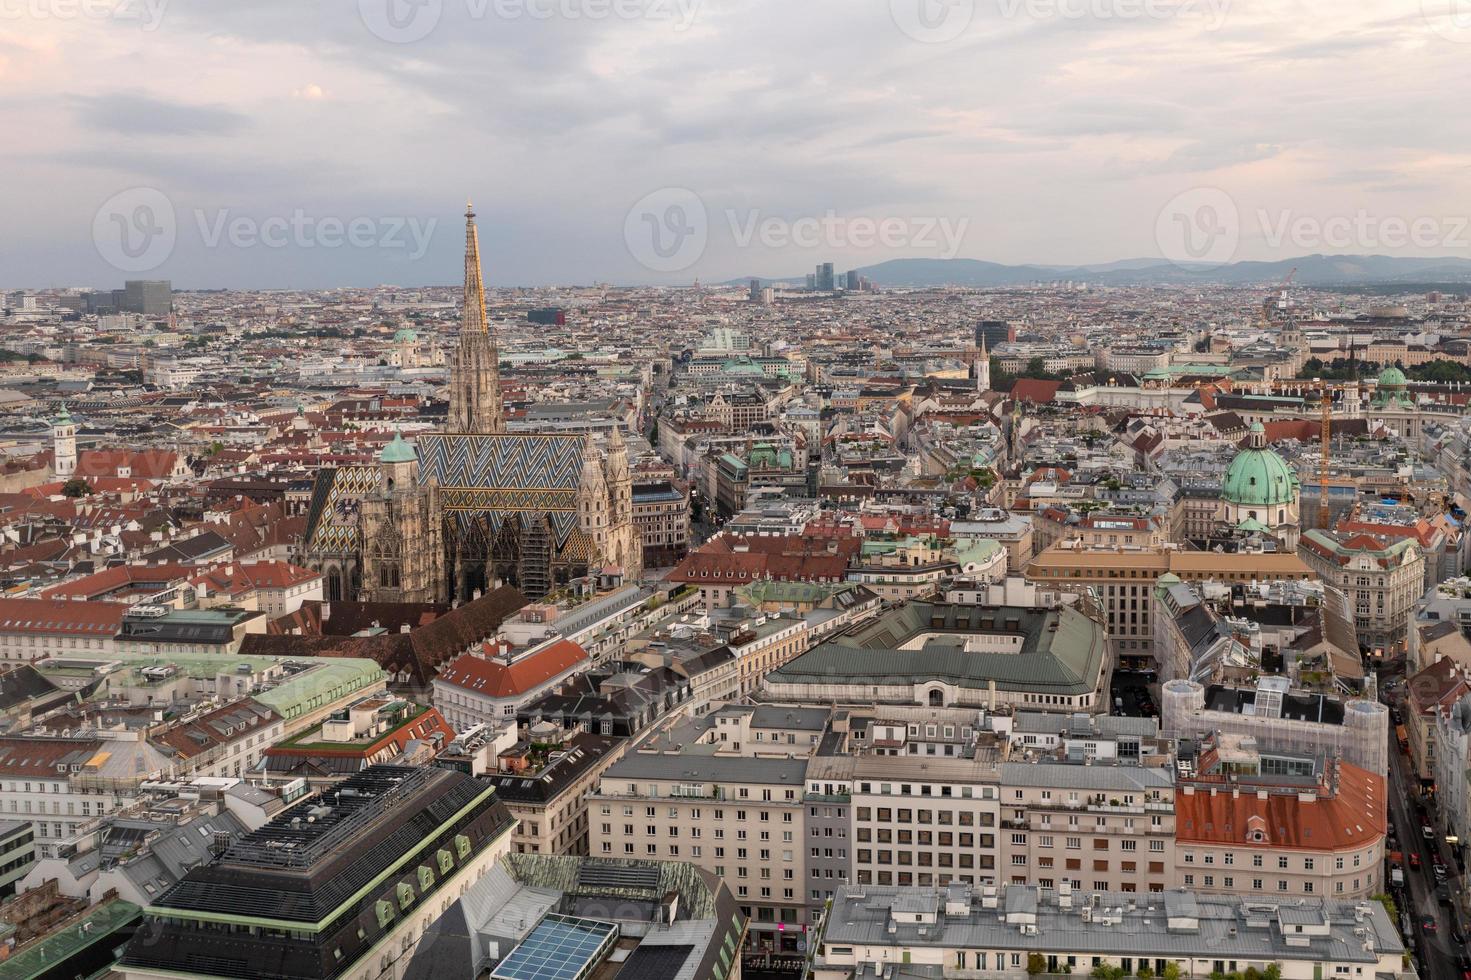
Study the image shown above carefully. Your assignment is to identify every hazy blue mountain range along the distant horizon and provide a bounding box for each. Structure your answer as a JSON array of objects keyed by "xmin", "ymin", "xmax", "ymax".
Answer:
[{"xmin": 731, "ymin": 255, "xmax": 1471, "ymax": 287}]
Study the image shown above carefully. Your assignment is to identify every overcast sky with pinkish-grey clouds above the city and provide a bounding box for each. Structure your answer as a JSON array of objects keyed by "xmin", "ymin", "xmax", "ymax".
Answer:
[{"xmin": 0, "ymin": 0, "xmax": 1471, "ymax": 288}]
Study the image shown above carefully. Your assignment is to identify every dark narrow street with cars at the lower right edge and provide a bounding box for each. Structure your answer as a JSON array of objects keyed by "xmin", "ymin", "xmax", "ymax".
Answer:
[{"xmin": 1386, "ymin": 709, "xmax": 1465, "ymax": 980}]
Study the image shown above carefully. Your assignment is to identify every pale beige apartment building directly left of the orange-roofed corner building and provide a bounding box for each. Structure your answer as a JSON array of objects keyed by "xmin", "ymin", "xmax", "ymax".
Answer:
[{"xmin": 1000, "ymin": 762, "xmax": 1175, "ymax": 893}]
